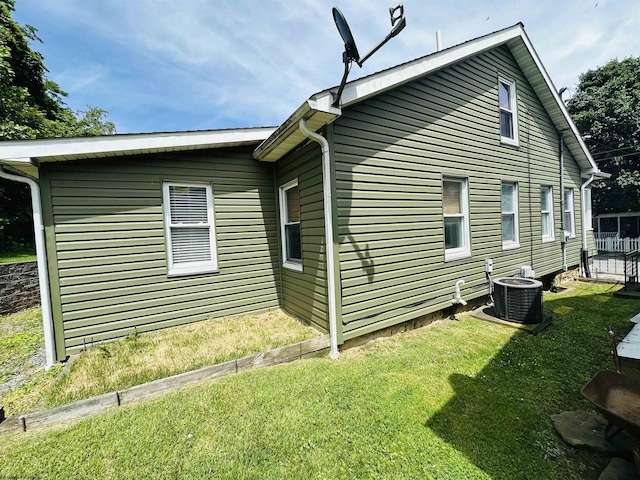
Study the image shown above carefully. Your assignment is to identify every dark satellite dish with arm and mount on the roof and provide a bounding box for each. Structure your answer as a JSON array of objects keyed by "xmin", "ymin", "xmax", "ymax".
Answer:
[{"xmin": 332, "ymin": 5, "xmax": 407, "ymax": 107}]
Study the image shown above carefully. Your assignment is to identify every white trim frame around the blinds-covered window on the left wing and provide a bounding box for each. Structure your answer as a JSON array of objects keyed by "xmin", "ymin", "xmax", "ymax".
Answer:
[{"xmin": 162, "ymin": 182, "xmax": 218, "ymax": 277}]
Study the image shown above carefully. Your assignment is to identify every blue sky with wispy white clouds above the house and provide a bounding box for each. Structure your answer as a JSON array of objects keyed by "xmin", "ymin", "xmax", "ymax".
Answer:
[{"xmin": 14, "ymin": 0, "xmax": 640, "ymax": 133}]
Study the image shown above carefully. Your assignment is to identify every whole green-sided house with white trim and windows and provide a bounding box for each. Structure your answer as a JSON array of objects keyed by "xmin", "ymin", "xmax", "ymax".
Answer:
[{"xmin": 0, "ymin": 24, "xmax": 603, "ymax": 364}]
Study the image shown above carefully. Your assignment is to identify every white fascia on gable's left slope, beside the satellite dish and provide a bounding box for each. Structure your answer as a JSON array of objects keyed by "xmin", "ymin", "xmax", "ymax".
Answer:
[{"xmin": 311, "ymin": 24, "xmax": 524, "ymax": 108}]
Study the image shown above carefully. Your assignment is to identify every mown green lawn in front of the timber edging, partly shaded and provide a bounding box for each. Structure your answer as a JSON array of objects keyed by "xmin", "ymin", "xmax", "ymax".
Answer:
[{"xmin": 0, "ymin": 283, "xmax": 640, "ymax": 480}]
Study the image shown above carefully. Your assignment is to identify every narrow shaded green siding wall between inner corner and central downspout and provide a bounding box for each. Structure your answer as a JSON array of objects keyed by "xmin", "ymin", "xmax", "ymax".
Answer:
[{"xmin": 276, "ymin": 143, "xmax": 329, "ymax": 332}]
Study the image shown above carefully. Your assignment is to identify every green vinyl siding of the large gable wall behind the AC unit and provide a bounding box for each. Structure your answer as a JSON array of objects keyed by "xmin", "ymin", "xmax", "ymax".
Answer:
[{"xmin": 333, "ymin": 47, "xmax": 592, "ymax": 339}]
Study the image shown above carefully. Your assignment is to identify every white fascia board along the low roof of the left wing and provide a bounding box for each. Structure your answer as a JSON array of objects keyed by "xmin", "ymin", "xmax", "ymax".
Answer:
[{"xmin": 0, "ymin": 127, "xmax": 276, "ymax": 162}]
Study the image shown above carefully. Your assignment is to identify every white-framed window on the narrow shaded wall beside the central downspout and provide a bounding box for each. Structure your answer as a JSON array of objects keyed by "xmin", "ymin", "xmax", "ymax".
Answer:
[{"xmin": 280, "ymin": 179, "xmax": 302, "ymax": 272}]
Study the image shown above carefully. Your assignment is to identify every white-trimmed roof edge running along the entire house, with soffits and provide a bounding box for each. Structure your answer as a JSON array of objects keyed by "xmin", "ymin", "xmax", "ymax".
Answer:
[{"xmin": 0, "ymin": 23, "xmax": 607, "ymax": 178}]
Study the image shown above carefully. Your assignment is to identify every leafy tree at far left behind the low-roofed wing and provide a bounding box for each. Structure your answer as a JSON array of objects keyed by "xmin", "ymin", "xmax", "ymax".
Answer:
[{"xmin": 0, "ymin": 0, "xmax": 115, "ymax": 251}]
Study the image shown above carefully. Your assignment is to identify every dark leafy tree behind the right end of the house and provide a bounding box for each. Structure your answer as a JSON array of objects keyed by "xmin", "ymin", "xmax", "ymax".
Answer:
[{"xmin": 568, "ymin": 57, "xmax": 640, "ymax": 214}]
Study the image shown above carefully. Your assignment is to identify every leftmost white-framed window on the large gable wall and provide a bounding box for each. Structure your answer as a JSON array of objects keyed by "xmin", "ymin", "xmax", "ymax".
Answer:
[{"xmin": 442, "ymin": 178, "xmax": 471, "ymax": 261}]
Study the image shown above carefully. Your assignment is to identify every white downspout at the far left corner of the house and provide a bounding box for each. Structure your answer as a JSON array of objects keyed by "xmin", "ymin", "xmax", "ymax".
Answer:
[{"xmin": 0, "ymin": 168, "xmax": 56, "ymax": 369}]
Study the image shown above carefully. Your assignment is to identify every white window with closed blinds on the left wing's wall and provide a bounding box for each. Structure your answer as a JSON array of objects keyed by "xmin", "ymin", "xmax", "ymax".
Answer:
[{"xmin": 162, "ymin": 183, "xmax": 218, "ymax": 275}]
